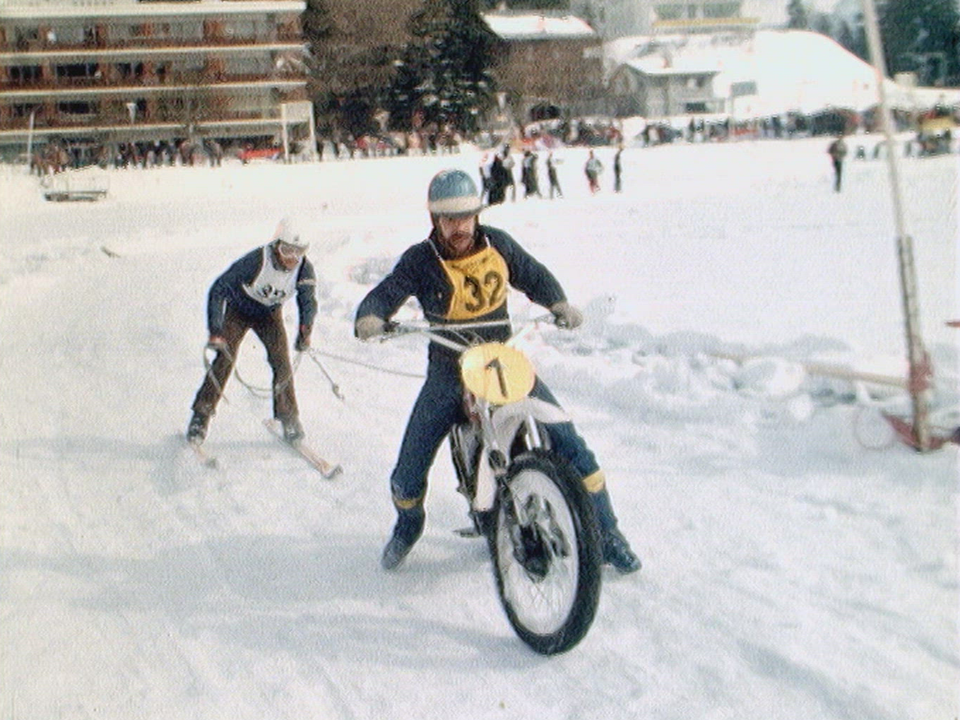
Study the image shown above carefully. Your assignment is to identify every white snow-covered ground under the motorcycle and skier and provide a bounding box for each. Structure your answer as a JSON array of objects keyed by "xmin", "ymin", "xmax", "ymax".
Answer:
[{"xmin": 0, "ymin": 139, "xmax": 960, "ymax": 720}]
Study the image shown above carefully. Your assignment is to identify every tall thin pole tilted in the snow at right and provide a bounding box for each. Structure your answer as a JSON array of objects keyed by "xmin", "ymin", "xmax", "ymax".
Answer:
[{"xmin": 862, "ymin": 0, "xmax": 930, "ymax": 450}]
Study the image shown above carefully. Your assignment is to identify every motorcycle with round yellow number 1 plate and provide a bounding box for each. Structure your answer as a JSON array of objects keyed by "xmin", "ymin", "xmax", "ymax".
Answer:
[{"xmin": 385, "ymin": 321, "xmax": 602, "ymax": 655}]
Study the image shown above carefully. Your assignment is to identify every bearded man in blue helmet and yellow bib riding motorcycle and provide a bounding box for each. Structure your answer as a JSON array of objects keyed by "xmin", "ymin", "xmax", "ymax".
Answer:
[{"xmin": 354, "ymin": 170, "xmax": 640, "ymax": 573}]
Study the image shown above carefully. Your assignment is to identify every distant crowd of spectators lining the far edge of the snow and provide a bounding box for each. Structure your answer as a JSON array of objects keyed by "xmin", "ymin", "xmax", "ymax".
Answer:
[{"xmin": 29, "ymin": 101, "xmax": 960, "ymax": 175}]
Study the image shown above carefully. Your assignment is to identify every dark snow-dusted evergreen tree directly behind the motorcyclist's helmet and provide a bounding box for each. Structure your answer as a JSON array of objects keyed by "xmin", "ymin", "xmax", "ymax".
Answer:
[{"xmin": 387, "ymin": 0, "xmax": 495, "ymax": 132}]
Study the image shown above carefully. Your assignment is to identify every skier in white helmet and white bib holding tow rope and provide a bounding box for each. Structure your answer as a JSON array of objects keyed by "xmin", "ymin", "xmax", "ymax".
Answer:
[{"xmin": 187, "ymin": 218, "xmax": 317, "ymax": 444}]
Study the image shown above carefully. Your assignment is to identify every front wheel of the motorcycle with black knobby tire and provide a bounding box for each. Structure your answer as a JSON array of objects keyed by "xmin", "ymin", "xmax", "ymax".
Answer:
[{"xmin": 491, "ymin": 451, "xmax": 602, "ymax": 655}]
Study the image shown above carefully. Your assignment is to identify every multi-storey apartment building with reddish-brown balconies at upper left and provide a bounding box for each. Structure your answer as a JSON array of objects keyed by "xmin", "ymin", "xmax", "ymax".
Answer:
[{"xmin": 0, "ymin": 0, "xmax": 312, "ymax": 154}]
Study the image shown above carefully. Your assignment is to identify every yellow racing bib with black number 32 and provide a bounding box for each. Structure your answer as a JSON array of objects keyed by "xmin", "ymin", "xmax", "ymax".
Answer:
[{"xmin": 441, "ymin": 247, "xmax": 510, "ymax": 320}]
